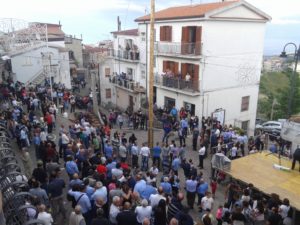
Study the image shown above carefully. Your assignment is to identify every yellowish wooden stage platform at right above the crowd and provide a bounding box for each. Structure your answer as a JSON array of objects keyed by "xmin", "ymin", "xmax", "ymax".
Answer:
[{"xmin": 226, "ymin": 151, "xmax": 300, "ymax": 210}]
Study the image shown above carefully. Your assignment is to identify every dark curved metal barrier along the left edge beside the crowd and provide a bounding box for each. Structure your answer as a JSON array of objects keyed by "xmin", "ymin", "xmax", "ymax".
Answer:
[{"xmin": 0, "ymin": 127, "xmax": 44, "ymax": 225}]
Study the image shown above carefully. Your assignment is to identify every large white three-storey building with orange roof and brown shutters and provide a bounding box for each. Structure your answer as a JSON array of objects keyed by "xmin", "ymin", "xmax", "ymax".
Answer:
[{"xmin": 135, "ymin": 1, "xmax": 271, "ymax": 134}]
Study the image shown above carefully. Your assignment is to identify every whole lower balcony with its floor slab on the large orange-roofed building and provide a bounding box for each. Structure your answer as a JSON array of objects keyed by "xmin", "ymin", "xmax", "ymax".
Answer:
[{"xmin": 154, "ymin": 75, "xmax": 200, "ymax": 96}]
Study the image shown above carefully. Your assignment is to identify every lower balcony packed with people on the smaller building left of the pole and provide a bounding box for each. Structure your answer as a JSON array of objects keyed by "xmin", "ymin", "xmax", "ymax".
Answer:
[{"xmin": 109, "ymin": 76, "xmax": 146, "ymax": 93}]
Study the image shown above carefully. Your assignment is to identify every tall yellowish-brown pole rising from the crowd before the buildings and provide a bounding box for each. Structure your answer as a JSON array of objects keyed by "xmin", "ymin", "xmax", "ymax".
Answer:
[{"xmin": 148, "ymin": 0, "xmax": 155, "ymax": 148}]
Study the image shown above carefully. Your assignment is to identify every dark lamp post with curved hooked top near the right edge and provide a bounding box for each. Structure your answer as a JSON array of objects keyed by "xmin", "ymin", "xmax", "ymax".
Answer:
[{"xmin": 280, "ymin": 42, "xmax": 300, "ymax": 118}]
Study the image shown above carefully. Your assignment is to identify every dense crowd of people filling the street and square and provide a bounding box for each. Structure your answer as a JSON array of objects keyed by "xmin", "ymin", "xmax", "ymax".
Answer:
[{"xmin": 0, "ymin": 71, "xmax": 292, "ymax": 225}]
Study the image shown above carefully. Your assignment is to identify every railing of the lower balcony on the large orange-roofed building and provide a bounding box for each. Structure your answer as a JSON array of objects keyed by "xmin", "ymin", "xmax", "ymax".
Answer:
[{"xmin": 154, "ymin": 75, "xmax": 199, "ymax": 92}]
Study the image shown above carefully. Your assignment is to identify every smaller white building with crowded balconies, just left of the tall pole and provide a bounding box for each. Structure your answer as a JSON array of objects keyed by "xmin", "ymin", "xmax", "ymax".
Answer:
[{"xmin": 99, "ymin": 29, "xmax": 147, "ymax": 111}]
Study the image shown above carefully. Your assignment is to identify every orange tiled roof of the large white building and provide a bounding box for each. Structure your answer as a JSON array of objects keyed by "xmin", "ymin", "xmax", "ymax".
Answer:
[{"xmin": 135, "ymin": 1, "xmax": 238, "ymax": 22}]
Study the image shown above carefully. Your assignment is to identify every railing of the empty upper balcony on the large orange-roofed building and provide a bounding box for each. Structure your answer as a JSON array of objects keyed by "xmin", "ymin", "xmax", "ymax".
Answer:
[{"xmin": 156, "ymin": 42, "xmax": 201, "ymax": 56}]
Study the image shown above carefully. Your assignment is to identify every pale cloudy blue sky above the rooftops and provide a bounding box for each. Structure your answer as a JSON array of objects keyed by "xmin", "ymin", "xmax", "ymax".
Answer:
[{"xmin": 0, "ymin": 0, "xmax": 300, "ymax": 55}]
